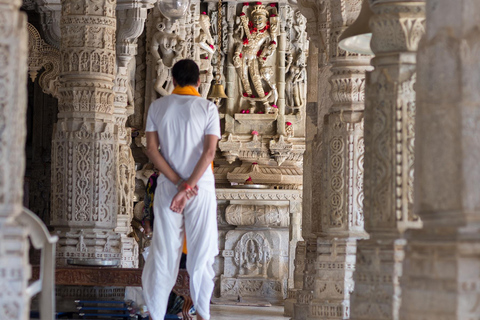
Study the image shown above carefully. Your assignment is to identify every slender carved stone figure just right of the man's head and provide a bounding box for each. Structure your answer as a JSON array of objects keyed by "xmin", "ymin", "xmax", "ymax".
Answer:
[{"xmin": 195, "ymin": 12, "xmax": 215, "ymax": 98}]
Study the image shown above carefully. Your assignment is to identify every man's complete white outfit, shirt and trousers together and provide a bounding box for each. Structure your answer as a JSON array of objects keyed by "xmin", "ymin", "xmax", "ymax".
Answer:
[{"xmin": 142, "ymin": 94, "xmax": 220, "ymax": 320}]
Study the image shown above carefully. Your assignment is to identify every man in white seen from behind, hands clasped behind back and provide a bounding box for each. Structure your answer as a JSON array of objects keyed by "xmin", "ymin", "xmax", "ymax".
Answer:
[{"xmin": 142, "ymin": 60, "xmax": 221, "ymax": 320}]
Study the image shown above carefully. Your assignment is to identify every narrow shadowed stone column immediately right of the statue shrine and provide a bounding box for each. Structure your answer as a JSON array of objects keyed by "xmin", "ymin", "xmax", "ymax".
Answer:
[{"xmin": 293, "ymin": 0, "xmax": 332, "ymax": 320}]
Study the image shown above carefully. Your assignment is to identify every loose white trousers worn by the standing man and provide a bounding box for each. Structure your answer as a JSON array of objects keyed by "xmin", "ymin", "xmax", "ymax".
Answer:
[{"xmin": 142, "ymin": 181, "xmax": 218, "ymax": 320}]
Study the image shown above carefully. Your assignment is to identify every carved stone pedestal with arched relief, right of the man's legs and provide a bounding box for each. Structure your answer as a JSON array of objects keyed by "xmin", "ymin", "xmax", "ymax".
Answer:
[{"xmin": 215, "ymin": 189, "xmax": 301, "ymax": 304}]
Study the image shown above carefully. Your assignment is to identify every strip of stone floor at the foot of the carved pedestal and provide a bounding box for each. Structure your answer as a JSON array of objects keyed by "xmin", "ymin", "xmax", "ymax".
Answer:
[{"xmin": 210, "ymin": 305, "xmax": 290, "ymax": 320}]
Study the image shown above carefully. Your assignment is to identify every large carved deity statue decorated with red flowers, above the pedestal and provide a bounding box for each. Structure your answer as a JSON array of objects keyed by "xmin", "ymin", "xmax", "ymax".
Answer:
[{"xmin": 233, "ymin": 4, "xmax": 278, "ymax": 111}]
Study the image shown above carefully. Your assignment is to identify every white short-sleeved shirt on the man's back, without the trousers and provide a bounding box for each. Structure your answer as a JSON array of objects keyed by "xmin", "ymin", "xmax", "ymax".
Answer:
[{"xmin": 146, "ymin": 94, "xmax": 221, "ymax": 187}]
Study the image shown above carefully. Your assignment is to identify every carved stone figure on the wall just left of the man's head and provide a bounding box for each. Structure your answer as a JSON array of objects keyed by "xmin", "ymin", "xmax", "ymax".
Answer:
[{"xmin": 150, "ymin": 17, "xmax": 185, "ymax": 96}]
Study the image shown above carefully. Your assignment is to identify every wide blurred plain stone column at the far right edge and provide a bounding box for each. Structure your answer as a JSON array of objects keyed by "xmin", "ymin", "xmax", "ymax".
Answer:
[{"xmin": 400, "ymin": 0, "xmax": 480, "ymax": 320}]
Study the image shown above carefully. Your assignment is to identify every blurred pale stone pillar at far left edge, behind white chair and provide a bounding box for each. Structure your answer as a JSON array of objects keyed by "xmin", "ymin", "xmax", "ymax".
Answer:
[{"xmin": 0, "ymin": 0, "xmax": 31, "ymax": 320}]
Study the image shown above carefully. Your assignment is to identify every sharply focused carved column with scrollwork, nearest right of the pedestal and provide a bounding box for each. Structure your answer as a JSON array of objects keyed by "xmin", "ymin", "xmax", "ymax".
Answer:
[{"xmin": 308, "ymin": 0, "xmax": 370, "ymax": 319}]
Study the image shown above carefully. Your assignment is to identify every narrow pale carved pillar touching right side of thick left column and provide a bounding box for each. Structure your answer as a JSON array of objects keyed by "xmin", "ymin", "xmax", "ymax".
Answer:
[{"xmin": 114, "ymin": 0, "xmax": 153, "ymax": 268}]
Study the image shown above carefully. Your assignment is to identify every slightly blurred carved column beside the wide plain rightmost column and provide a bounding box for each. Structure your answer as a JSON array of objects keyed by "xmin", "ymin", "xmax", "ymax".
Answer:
[{"xmin": 352, "ymin": 1, "xmax": 425, "ymax": 320}]
